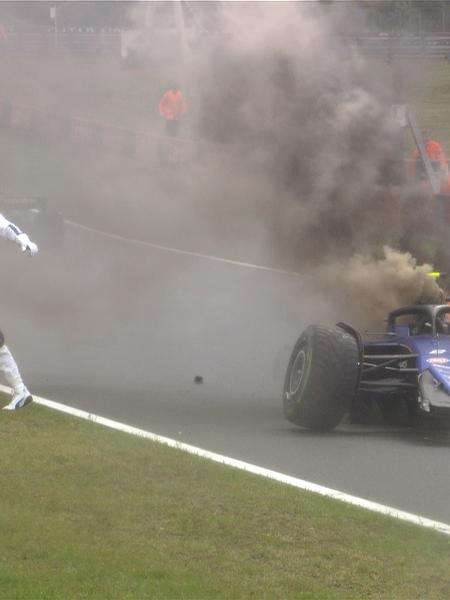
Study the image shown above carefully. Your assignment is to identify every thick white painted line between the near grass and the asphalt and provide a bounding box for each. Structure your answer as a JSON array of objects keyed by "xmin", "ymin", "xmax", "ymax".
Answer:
[{"xmin": 0, "ymin": 385, "xmax": 450, "ymax": 535}]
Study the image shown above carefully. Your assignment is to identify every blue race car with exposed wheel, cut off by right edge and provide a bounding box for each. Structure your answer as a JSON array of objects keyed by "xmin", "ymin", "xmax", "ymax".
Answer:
[{"xmin": 283, "ymin": 304, "xmax": 450, "ymax": 431}]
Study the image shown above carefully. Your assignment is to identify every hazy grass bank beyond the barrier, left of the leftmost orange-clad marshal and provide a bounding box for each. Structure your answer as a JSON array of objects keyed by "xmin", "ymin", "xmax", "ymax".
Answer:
[{"xmin": 0, "ymin": 55, "xmax": 171, "ymax": 128}]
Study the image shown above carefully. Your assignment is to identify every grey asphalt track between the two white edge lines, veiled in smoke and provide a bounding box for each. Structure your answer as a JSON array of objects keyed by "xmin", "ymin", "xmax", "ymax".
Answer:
[{"xmin": 0, "ymin": 228, "xmax": 450, "ymax": 523}]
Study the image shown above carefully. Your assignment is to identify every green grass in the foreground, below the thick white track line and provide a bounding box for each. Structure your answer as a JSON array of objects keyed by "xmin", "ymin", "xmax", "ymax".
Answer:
[{"xmin": 0, "ymin": 397, "xmax": 450, "ymax": 600}]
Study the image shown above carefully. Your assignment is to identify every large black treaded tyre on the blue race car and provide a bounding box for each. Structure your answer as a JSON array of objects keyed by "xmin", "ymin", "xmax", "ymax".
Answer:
[{"xmin": 283, "ymin": 325, "xmax": 359, "ymax": 431}]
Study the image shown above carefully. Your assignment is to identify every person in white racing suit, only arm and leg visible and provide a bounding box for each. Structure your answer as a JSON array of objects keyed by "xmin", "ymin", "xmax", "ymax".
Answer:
[{"xmin": 0, "ymin": 214, "xmax": 38, "ymax": 410}]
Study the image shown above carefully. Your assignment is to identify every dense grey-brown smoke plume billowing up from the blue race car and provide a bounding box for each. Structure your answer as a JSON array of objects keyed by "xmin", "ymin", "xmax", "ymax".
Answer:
[{"xmin": 171, "ymin": 3, "xmax": 439, "ymax": 322}]
